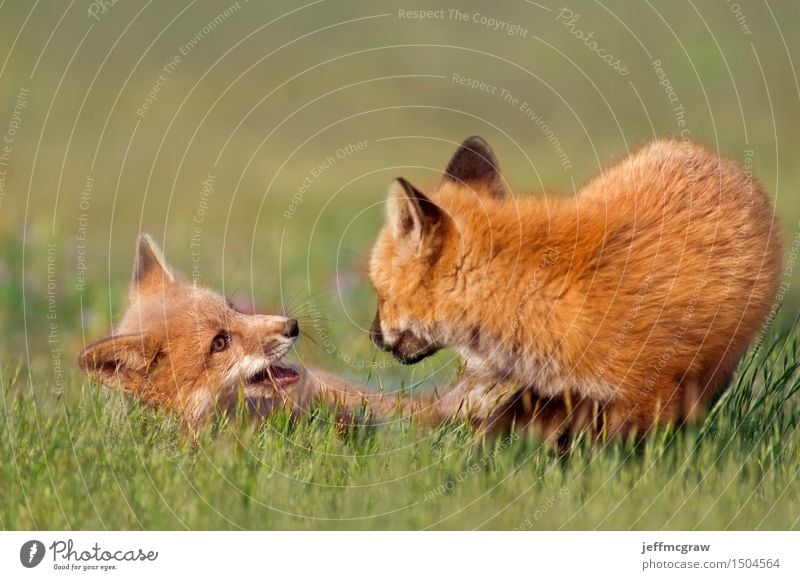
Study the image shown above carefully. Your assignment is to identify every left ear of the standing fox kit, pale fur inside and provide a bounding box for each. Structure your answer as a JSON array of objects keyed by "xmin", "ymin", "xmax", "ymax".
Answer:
[{"xmin": 388, "ymin": 177, "xmax": 445, "ymax": 244}]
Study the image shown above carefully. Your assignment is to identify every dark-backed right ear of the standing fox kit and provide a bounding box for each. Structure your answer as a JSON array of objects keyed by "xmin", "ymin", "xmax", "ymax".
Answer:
[{"xmin": 443, "ymin": 135, "xmax": 506, "ymax": 199}]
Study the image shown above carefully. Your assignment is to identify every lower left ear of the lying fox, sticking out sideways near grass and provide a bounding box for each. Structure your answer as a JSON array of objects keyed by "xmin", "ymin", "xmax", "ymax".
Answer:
[{"xmin": 78, "ymin": 334, "xmax": 161, "ymax": 391}]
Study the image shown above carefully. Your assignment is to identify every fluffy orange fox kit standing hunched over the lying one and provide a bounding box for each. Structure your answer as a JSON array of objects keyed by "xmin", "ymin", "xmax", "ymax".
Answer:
[{"xmin": 370, "ymin": 137, "xmax": 781, "ymax": 435}]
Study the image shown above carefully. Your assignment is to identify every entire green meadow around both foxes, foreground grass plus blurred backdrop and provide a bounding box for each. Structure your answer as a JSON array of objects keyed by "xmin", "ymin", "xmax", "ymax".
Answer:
[{"xmin": 0, "ymin": 0, "xmax": 800, "ymax": 530}]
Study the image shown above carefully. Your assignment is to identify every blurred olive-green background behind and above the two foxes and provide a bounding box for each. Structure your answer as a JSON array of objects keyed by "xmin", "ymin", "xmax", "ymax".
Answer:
[{"xmin": 0, "ymin": 0, "xmax": 800, "ymax": 384}]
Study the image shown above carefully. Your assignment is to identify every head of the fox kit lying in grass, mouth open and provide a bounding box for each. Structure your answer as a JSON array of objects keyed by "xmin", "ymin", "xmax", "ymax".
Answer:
[{"xmin": 78, "ymin": 234, "xmax": 300, "ymax": 424}]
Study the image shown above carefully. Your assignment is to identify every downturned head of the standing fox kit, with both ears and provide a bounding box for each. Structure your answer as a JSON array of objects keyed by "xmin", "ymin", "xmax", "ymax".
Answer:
[{"xmin": 369, "ymin": 136, "xmax": 506, "ymax": 364}]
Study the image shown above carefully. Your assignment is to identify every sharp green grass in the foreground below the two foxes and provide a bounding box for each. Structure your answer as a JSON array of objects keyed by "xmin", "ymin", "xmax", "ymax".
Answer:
[{"xmin": 0, "ymin": 324, "xmax": 800, "ymax": 529}]
